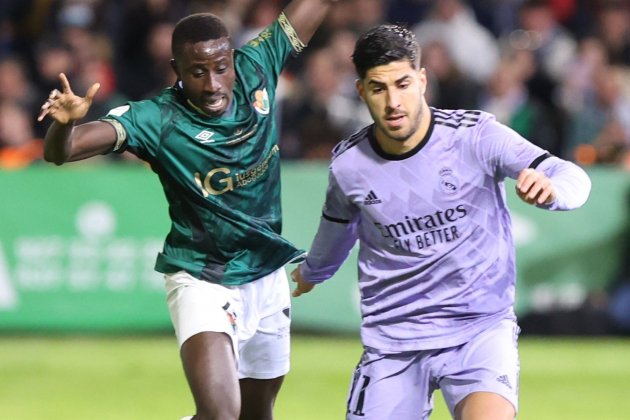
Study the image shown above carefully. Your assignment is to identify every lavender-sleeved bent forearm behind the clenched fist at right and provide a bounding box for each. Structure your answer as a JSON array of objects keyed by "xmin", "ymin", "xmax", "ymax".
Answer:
[{"xmin": 539, "ymin": 157, "xmax": 591, "ymax": 210}]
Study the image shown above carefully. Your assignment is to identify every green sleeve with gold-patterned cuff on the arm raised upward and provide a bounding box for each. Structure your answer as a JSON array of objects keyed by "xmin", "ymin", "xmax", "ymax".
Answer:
[{"xmin": 239, "ymin": 13, "xmax": 306, "ymax": 84}]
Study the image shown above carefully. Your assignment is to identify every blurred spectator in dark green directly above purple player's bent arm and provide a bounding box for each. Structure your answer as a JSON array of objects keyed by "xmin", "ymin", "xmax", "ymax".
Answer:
[{"xmin": 481, "ymin": 45, "xmax": 563, "ymax": 156}]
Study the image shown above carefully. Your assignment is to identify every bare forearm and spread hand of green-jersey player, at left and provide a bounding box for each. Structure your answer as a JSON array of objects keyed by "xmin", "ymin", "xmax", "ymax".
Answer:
[{"xmin": 37, "ymin": 73, "xmax": 116, "ymax": 165}]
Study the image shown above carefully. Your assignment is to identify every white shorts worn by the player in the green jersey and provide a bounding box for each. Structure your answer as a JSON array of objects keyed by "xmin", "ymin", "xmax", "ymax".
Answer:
[{"xmin": 164, "ymin": 267, "xmax": 291, "ymax": 379}]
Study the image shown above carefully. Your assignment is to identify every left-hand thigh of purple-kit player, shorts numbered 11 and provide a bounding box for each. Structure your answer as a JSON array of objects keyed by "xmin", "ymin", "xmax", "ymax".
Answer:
[{"xmin": 346, "ymin": 349, "xmax": 433, "ymax": 420}]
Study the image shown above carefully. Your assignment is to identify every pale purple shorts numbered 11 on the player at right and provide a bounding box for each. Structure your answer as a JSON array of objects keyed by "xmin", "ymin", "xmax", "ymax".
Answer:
[{"xmin": 346, "ymin": 319, "xmax": 520, "ymax": 420}]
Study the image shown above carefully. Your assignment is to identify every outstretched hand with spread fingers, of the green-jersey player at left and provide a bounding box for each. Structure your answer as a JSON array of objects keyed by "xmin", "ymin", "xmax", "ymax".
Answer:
[{"xmin": 37, "ymin": 73, "xmax": 101, "ymax": 124}]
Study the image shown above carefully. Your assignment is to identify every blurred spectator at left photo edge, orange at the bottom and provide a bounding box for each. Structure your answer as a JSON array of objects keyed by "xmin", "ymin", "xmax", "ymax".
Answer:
[{"xmin": 0, "ymin": 100, "xmax": 43, "ymax": 169}]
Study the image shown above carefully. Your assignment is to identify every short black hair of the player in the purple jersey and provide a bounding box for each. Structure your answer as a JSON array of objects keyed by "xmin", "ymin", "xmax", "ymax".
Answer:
[{"xmin": 352, "ymin": 24, "xmax": 420, "ymax": 79}]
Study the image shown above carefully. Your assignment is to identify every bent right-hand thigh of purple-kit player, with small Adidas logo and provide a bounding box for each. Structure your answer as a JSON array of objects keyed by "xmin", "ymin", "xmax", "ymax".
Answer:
[{"xmin": 439, "ymin": 320, "xmax": 520, "ymax": 418}]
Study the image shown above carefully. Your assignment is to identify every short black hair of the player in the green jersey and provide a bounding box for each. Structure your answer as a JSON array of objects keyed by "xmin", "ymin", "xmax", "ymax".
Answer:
[{"xmin": 171, "ymin": 13, "xmax": 230, "ymax": 57}]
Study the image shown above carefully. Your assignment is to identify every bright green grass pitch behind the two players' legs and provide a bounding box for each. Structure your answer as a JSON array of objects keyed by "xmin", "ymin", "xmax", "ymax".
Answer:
[{"xmin": 0, "ymin": 335, "xmax": 630, "ymax": 420}]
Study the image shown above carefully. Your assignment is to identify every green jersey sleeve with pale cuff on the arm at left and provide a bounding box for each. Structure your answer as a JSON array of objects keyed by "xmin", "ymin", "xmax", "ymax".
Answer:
[{"xmin": 99, "ymin": 101, "xmax": 162, "ymax": 161}]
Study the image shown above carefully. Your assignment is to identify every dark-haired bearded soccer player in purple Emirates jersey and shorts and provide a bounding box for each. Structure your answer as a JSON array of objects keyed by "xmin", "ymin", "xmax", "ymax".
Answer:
[{"xmin": 292, "ymin": 25, "xmax": 591, "ymax": 420}]
